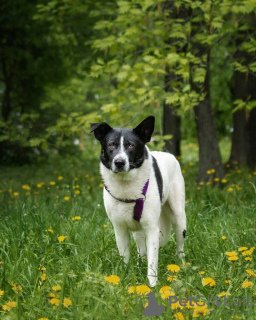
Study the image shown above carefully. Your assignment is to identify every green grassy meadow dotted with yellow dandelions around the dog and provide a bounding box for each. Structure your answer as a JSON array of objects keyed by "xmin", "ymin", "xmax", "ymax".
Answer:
[{"xmin": 0, "ymin": 142, "xmax": 256, "ymax": 320}]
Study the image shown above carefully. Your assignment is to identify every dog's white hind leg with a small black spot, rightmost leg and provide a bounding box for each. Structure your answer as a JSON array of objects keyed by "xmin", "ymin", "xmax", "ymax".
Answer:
[{"xmin": 168, "ymin": 177, "xmax": 186, "ymax": 260}]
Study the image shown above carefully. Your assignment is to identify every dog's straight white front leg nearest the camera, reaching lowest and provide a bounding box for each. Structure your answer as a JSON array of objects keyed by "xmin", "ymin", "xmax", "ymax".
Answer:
[{"xmin": 147, "ymin": 228, "xmax": 159, "ymax": 287}]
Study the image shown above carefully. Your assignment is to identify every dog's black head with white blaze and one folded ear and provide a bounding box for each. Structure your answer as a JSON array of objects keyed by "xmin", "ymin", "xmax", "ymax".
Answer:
[{"xmin": 90, "ymin": 116, "xmax": 155, "ymax": 173}]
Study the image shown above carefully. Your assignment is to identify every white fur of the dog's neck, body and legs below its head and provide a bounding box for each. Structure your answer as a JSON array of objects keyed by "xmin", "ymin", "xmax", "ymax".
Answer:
[{"xmin": 100, "ymin": 148, "xmax": 186, "ymax": 286}]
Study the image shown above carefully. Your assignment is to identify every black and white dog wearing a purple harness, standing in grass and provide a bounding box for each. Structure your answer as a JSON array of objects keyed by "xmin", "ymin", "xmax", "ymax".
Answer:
[{"xmin": 90, "ymin": 116, "xmax": 186, "ymax": 287}]
